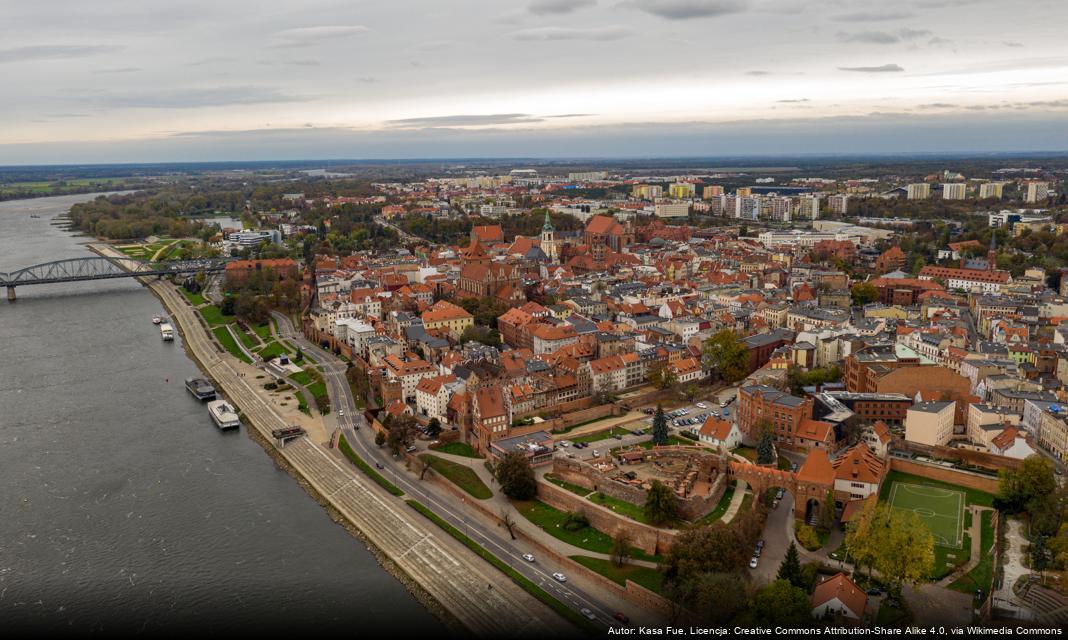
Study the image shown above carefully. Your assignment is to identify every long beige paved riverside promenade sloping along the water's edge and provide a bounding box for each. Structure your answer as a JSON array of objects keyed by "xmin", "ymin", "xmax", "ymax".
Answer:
[{"xmin": 93, "ymin": 245, "xmax": 577, "ymax": 637}]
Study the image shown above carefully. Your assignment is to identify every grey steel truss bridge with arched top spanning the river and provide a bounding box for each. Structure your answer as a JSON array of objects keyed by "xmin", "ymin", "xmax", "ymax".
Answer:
[{"xmin": 0, "ymin": 257, "xmax": 230, "ymax": 300}]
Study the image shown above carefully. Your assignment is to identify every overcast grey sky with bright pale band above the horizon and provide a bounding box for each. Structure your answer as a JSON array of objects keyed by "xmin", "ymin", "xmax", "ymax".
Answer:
[{"xmin": 0, "ymin": 0, "xmax": 1068, "ymax": 165}]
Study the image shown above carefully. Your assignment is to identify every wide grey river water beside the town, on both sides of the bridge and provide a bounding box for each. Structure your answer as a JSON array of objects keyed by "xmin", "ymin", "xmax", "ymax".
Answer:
[{"xmin": 0, "ymin": 196, "xmax": 444, "ymax": 637}]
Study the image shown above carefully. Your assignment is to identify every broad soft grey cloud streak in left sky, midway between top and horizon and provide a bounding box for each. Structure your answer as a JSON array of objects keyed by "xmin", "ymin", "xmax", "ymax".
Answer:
[{"xmin": 81, "ymin": 87, "xmax": 309, "ymax": 109}]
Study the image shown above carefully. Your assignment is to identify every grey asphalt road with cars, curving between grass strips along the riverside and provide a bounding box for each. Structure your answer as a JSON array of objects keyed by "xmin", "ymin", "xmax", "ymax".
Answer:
[{"xmin": 274, "ymin": 313, "xmax": 617, "ymax": 626}]
